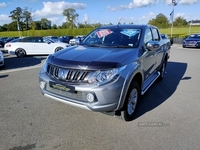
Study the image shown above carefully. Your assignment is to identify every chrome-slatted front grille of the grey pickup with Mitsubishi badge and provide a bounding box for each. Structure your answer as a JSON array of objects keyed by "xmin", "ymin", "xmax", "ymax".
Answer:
[{"xmin": 47, "ymin": 64, "xmax": 90, "ymax": 82}]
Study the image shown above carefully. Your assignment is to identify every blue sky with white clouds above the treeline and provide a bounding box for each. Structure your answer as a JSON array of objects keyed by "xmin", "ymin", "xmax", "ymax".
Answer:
[{"xmin": 0, "ymin": 0, "xmax": 200, "ymax": 26}]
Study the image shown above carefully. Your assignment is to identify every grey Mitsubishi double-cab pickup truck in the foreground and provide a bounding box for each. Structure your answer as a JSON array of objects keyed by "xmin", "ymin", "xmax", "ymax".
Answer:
[{"xmin": 39, "ymin": 25, "xmax": 170, "ymax": 121}]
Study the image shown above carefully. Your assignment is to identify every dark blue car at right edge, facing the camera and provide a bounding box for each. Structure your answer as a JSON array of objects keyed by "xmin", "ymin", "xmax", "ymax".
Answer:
[{"xmin": 183, "ymin": 34, "xmax": 200, "ymax": 48}]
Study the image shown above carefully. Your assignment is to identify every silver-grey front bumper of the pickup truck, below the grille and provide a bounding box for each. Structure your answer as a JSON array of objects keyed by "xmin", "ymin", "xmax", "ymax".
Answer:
[{"xmin": 39, "ymin": 70, "xmax": 124, "ymax": 112}]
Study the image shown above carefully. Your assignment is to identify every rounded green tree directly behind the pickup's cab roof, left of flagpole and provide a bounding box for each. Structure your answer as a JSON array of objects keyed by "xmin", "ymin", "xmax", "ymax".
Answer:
[{"xmin": 148, "ymin": 13, "xmax": 169, "ymax": 28}]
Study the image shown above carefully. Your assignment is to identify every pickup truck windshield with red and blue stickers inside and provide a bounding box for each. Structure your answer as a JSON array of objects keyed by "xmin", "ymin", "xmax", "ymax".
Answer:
[{"xmin": 81, "ymin": 28, "xmax": 141, "ymax": 48}]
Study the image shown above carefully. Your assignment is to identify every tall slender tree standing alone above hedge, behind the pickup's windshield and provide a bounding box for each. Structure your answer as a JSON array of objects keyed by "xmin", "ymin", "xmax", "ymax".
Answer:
[{"xmin": 63, "ymin": 8, "xmax": 79, "ymax": 29}]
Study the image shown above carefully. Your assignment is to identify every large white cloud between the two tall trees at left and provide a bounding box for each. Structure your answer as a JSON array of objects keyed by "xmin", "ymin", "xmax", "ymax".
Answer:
[{"xmin": 33, "ymin": 1, "xmax": 86, "ymax": 17}]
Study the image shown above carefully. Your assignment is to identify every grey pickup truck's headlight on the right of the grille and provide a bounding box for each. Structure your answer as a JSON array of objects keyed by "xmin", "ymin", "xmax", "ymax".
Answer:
[{"xmin": 88, "ymin": 66, "xmax": 126, "ymax": 84}]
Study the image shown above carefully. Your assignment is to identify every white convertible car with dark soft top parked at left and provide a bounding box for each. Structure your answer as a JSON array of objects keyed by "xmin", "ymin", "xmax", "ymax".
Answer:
[{"xmin": 4, "ymin": 36, "xmax": 70, "ymax": 57}]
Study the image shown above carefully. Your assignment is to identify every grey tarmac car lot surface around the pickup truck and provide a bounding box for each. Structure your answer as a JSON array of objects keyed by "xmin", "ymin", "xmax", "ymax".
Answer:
[{"xmin": 0, "ymin": 45, "xmax": 200, "ymax": 150}]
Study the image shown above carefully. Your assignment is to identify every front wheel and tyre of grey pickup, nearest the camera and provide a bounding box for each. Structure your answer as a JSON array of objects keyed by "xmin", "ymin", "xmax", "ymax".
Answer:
[{"xmin": 120, "ymin": 81, "xmax": 140, "ymax": 121}]
